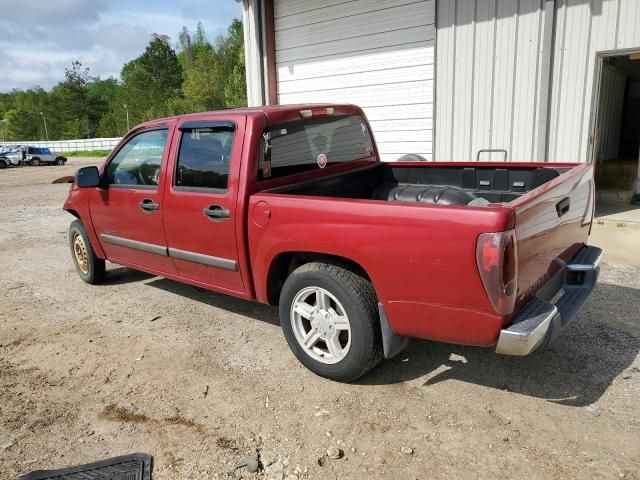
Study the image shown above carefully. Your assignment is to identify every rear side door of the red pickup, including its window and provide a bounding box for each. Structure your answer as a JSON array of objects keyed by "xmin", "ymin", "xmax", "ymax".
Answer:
[{"xmin": 162, "ymin": 116, "xmax": 246, "ymax": 293}]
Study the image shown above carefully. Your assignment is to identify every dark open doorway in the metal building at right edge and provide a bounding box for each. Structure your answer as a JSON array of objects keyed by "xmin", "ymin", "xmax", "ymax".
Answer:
[{"xmin": 593, "ymin": 50, "xmax": 640, "ymax": 212}]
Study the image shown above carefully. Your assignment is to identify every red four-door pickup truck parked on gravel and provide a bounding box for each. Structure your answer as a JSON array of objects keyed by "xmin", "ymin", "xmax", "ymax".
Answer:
[{"xmin": 64, "ymin": 105, "xmax": 602, "ymax": 381}]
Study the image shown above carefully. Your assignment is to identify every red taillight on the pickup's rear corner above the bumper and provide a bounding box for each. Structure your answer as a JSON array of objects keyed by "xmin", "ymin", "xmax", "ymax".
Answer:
[{"xmin": 476, "ymin": 230, "xmax": 518, "ymax": 315}]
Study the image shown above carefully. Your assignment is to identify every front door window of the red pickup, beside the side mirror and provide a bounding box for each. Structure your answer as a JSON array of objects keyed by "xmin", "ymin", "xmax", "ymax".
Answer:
[{"xmin": 107, "ymin": 129, "xmax": 168, "ymax": 187}]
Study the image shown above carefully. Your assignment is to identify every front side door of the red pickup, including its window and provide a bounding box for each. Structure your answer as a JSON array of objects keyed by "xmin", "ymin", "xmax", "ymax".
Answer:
[{"xmin": 90, "ymin": 127, "xmax": 176, "ymax": 275}]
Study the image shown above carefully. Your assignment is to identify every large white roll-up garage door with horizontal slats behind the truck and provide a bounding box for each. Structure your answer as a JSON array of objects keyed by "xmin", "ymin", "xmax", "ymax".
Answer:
[{"xmin": 274, "ymin": 0, "xmax": 435, "ymax": 160}]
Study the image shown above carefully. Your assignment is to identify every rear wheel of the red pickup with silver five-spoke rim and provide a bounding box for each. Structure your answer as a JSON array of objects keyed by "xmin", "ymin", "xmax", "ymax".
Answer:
[{"xmin": 279, "ymin": 263, "xmax": 383, "ymax": 382}]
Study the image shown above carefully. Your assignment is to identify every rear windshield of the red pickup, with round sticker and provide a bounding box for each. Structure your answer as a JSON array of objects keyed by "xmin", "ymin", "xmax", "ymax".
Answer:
[{"xmin": 258, "ymin": 115, "xmax": 373, "ymax": 180}]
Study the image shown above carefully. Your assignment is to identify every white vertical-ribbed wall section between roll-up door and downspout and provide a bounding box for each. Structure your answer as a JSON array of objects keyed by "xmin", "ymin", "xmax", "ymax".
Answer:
[{"xmin": 435, "ymin": 0, "xmax": 553, "ymax": 161}]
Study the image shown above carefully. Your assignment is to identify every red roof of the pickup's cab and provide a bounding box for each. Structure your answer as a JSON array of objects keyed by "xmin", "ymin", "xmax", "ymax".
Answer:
[{"xmin": 135, "ymin": 103, "xmax": 362, "ymax": 129}]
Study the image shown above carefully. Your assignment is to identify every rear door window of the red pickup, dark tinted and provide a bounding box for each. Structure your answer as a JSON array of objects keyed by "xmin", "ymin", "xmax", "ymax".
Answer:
[{"xmin": 174, "ymin": 127, "xmax": 234, "ymax": 190}]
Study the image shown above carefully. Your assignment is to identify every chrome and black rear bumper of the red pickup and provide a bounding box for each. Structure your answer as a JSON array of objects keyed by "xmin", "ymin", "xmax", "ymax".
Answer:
[{"xmin": 496, "ymin": 246, "xmax": 602, "ymax": 355}]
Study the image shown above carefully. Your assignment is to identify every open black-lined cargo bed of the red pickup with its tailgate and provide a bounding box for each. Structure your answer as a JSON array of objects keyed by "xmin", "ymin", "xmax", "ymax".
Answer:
[{"xmin": 264, "ymin": 162, "xmax": 593, "ymax": 323}]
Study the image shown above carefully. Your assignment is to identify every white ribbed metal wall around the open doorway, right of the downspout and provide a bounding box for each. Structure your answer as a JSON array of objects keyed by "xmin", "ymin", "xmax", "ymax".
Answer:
[{"xmin": 548, "ymin": 0, "xmax": 640, "ymax": 162}]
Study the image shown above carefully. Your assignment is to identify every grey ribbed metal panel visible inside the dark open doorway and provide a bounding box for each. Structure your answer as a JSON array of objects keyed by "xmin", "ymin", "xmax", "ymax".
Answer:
[{"xmin": 598, "ymin": 65, "xmax": 627, "ymax": 160}]
